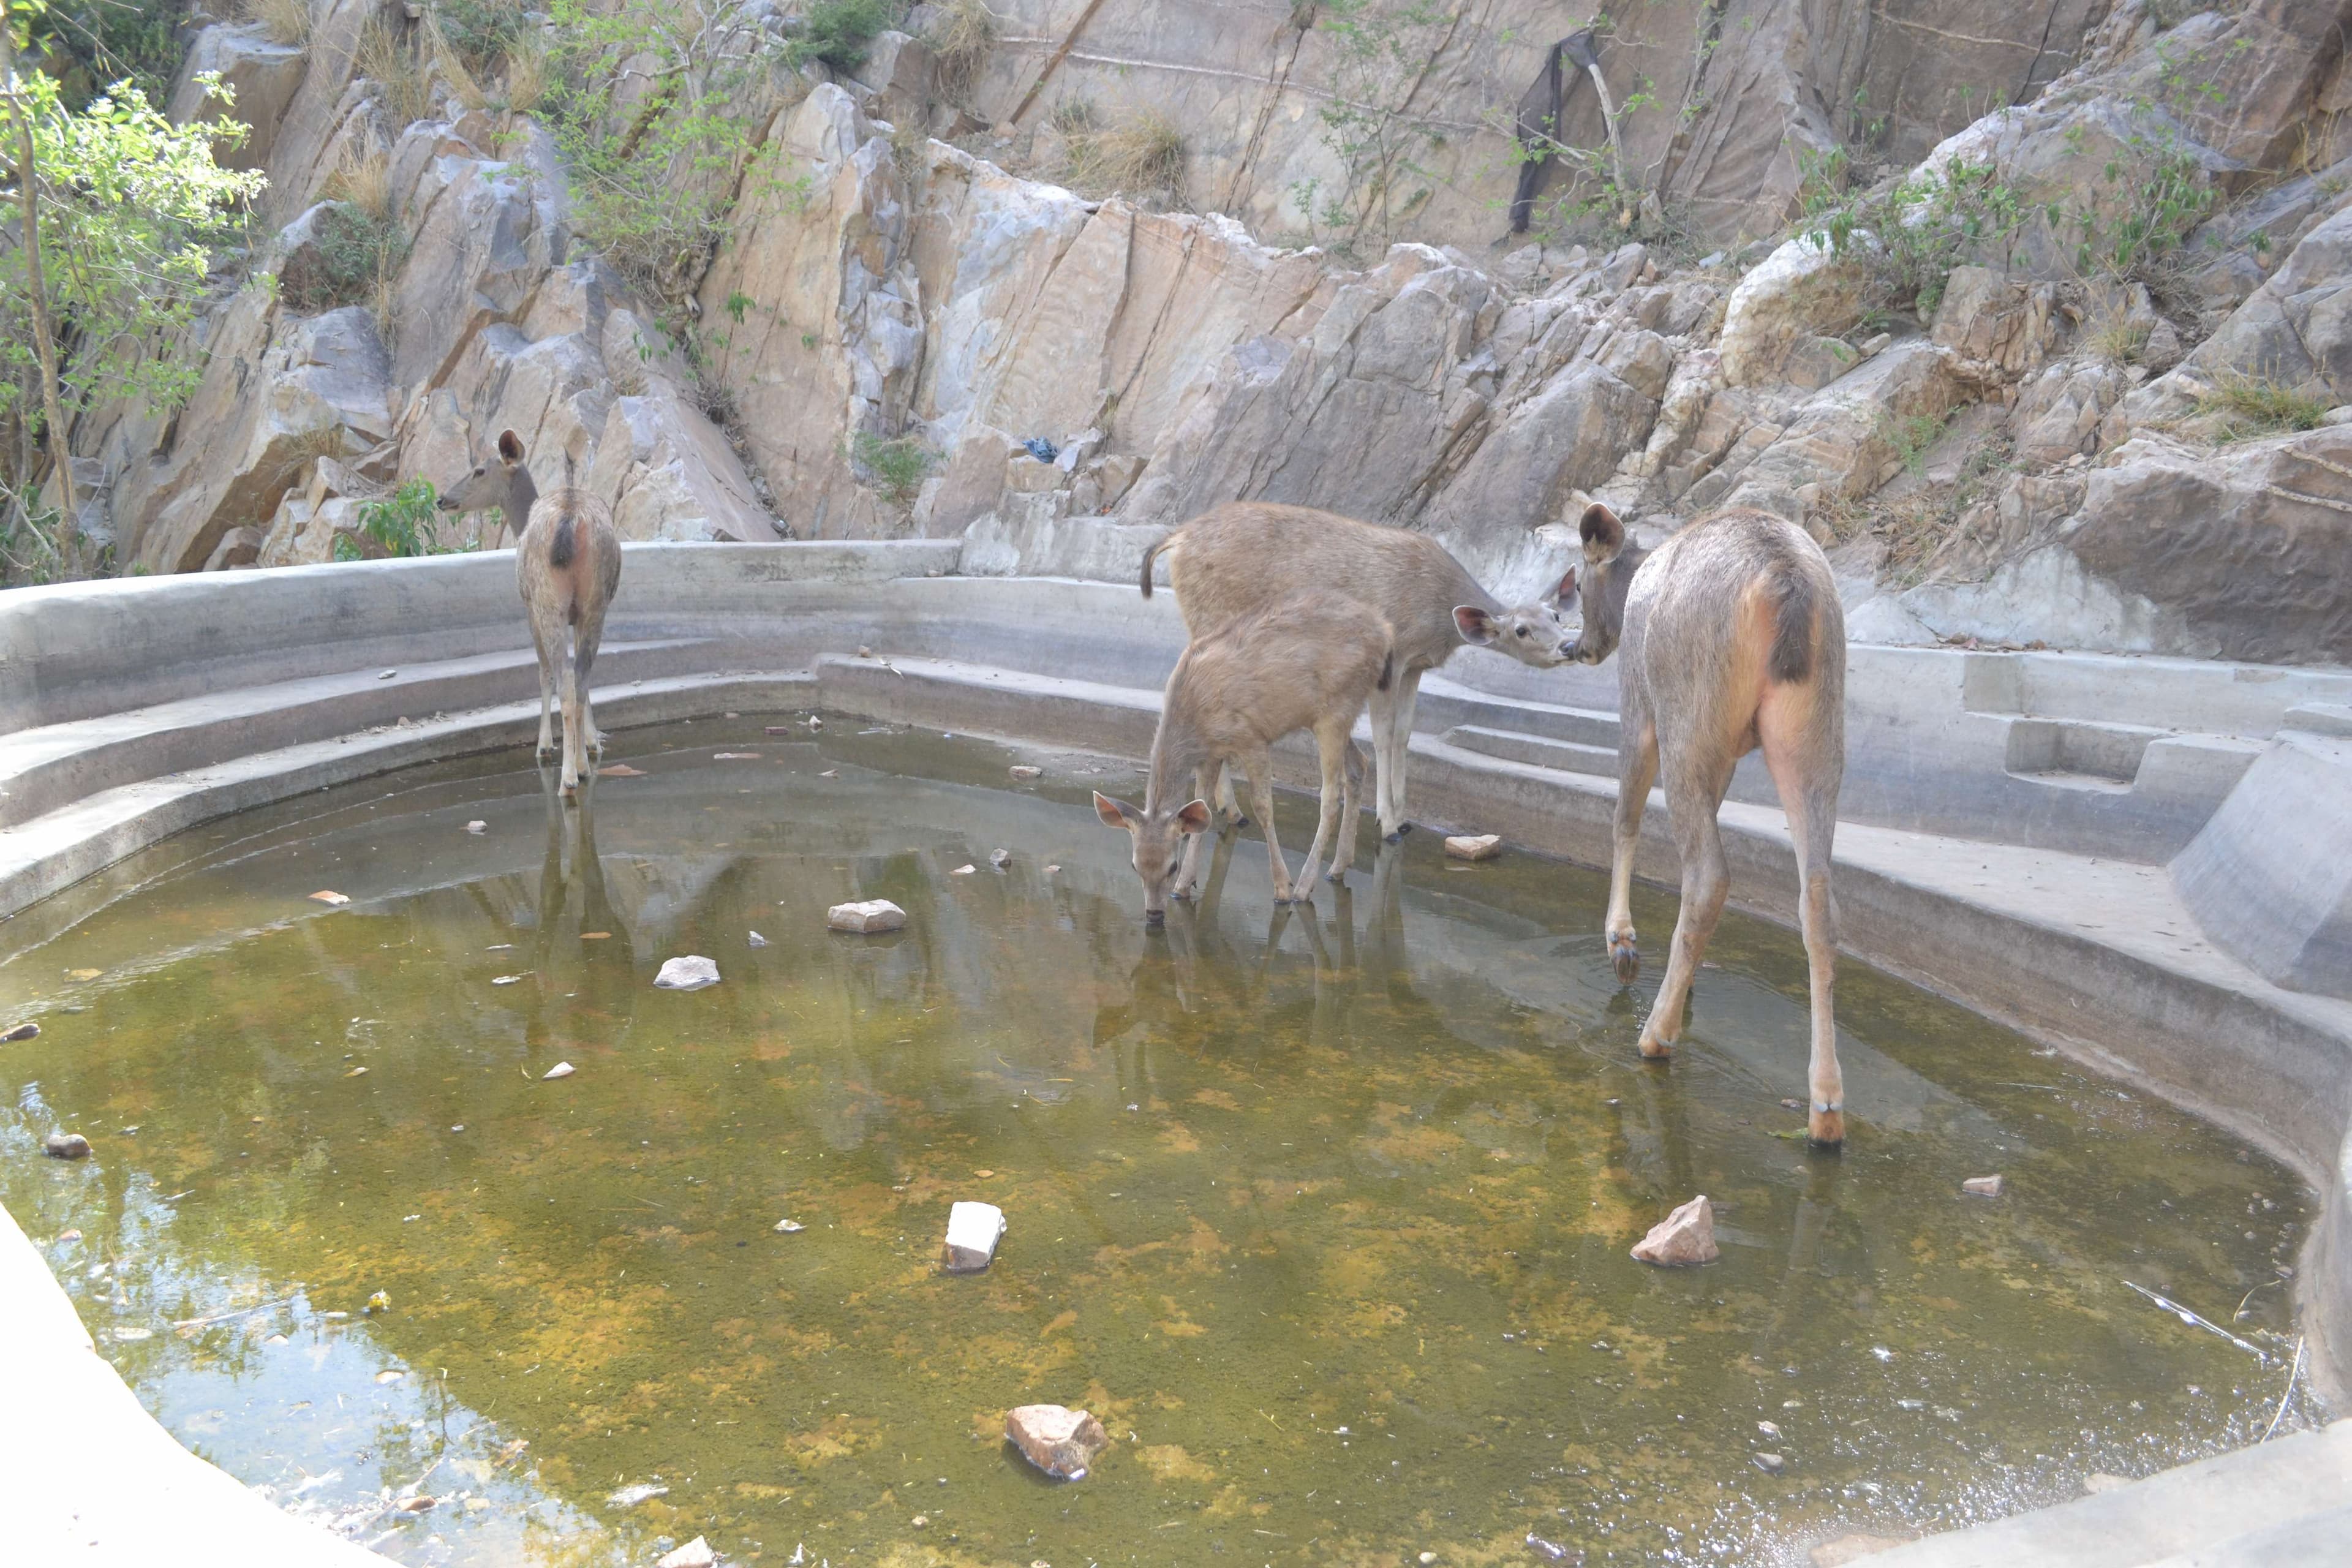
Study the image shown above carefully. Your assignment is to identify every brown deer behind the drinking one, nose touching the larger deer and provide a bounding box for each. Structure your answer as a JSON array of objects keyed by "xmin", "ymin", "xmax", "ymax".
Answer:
[{"xmin": 1143, "ymin": 501, "xmax": 1576, "ymax": 844}]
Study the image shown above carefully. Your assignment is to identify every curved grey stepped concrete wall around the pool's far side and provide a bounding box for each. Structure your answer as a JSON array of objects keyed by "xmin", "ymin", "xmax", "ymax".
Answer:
[{"xmin": 0, "ymin": 541, "xmax": 2352, "ymax": 1561}]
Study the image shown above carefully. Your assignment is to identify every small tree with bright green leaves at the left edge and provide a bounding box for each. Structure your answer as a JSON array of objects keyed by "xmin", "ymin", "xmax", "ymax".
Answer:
[{"xmin": 0, "ymin": 0, "xmax": 263, "ymax": 571}]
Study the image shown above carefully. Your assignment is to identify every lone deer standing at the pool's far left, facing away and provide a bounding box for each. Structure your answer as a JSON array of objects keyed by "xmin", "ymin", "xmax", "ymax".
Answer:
[{"xmin": 440, "ymin": 430, "xmax": 621, "ymax": 799}]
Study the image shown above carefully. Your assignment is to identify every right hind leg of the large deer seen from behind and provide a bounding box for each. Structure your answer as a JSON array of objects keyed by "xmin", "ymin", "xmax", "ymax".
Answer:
[{"xmin": 1757, "ymin": 687, "xmax": 1846, "ymax": 1147}]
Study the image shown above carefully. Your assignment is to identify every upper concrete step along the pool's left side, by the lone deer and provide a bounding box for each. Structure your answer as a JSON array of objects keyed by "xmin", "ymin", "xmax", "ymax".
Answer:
[{"xmin": 0, "ymin": 625, "xmax": 710, "ymax": 827}]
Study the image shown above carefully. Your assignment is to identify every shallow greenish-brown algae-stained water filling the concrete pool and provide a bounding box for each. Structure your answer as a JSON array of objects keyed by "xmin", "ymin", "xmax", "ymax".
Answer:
[{"xmin": 0, "ymin": 715, "xmax": 2307, "ymax": 1568}]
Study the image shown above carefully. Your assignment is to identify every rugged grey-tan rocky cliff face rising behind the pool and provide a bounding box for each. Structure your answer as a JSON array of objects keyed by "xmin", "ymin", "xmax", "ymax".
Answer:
[{"xmin": 50, "ymin": 0, "xmax": 2352, "ymax": 663}]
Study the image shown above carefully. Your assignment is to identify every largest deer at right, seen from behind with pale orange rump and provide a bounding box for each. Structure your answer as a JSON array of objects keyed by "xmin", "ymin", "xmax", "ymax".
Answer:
[{"xmin": 1576, "ymin": 503, "xmax": 1846, "ymax": 1145}]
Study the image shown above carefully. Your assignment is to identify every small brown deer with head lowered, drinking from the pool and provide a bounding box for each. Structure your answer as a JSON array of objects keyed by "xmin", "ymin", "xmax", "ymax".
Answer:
[{"xmin": 1094, "ymin": 588, "xmax": 1392, "ymax": 926}]
